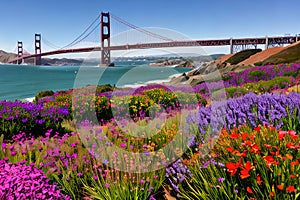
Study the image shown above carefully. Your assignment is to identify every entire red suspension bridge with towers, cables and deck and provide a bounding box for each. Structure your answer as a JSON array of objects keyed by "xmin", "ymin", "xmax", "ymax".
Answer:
[{"xmin": 8, "ymin": 12, "xmax": 300, "ymax": 65}]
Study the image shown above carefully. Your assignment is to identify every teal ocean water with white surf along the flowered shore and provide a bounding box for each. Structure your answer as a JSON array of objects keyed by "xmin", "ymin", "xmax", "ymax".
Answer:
[{"xmin": 0, "ymin": 61, "xmax": 190, "ymax": 100}]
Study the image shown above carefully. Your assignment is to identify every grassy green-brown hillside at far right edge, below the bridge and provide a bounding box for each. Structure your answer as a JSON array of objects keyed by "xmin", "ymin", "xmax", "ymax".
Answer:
[{"xmin": 257, "ymin": 42, "xmax": 300, "ymax": 65}]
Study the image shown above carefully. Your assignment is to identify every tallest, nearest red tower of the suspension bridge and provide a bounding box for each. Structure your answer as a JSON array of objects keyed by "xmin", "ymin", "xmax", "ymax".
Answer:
[{"xmin": 100, "ymin": 12, "xmax": 110, "ymax": 66}]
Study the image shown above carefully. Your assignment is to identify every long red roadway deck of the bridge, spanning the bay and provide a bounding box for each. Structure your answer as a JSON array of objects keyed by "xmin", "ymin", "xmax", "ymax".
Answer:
[{"xmin": 8, "ymin": 35, "xmax": 300, "ymax": 63}]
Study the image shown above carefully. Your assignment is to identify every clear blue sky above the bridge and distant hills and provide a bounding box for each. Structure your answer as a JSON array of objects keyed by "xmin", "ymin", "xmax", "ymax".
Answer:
[{"xmin": 0, "ymin": 0, "xmax": 300, "ymax": 53}]
